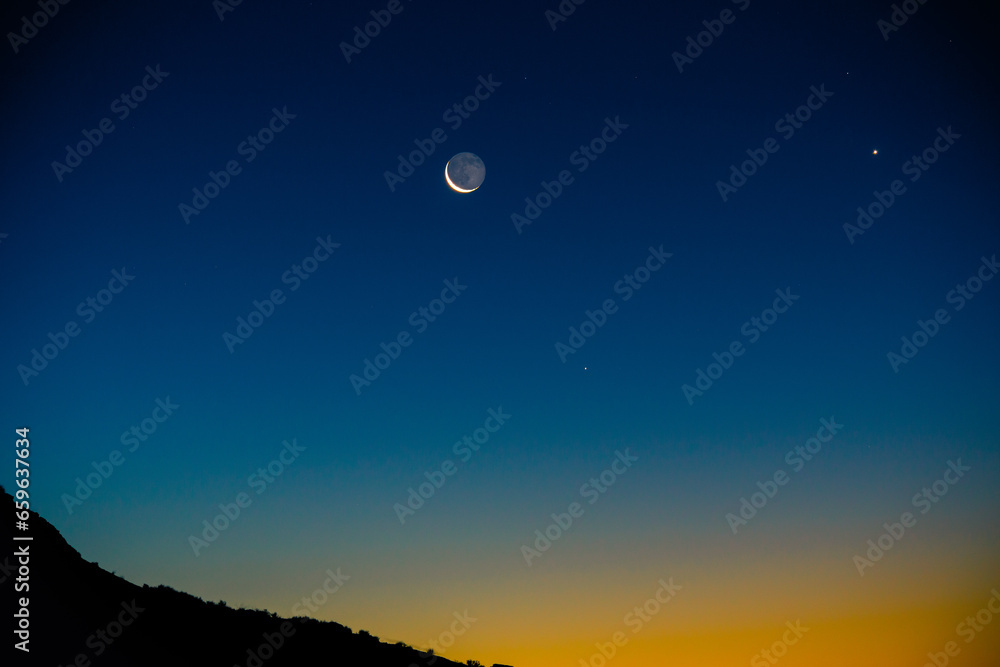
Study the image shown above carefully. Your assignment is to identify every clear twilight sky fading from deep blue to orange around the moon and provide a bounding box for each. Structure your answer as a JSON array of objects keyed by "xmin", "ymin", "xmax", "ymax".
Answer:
[{"xmin": 0, "ymin": 0, "xmax": 1000, "ymax": 667}]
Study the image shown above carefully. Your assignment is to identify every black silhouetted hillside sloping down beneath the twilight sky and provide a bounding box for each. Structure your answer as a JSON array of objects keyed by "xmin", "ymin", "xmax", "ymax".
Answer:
[{"xmin": 0, "ymin": 487, "xmax": 488, "ymax": 667}]
